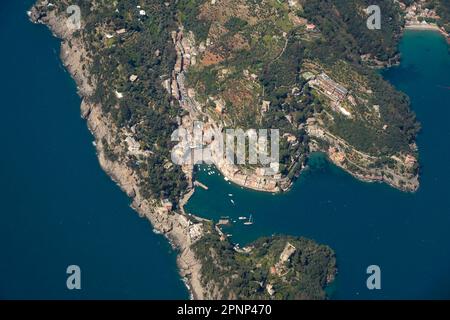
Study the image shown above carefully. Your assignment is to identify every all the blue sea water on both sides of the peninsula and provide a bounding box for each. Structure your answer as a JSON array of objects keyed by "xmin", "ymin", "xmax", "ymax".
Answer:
[{"xmin": 0, "ymin": 0, "xmax": 450, "ymax": 299}]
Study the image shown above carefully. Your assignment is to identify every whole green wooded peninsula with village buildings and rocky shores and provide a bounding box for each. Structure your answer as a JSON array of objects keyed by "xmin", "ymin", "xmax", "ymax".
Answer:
[{"xmin": 29, "ymin": 0, "xmax": 448, "ymax": 299}]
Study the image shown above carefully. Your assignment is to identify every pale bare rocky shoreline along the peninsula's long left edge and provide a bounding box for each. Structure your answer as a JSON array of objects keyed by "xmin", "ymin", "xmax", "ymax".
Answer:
[{"xmin": 28, "ymin": 3, "xmax": 208, "ymax": 299}]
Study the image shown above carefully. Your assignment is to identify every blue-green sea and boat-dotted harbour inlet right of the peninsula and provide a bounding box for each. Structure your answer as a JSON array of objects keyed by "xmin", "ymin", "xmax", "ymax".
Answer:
[{"xmin": 187, "ymin": 31, "xmax": 450, "ymax": 299}]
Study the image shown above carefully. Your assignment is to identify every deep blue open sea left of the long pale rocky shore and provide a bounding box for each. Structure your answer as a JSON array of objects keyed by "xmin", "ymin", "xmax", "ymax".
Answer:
[{"xmin": 0, "ymin": 0, "xmax": 188, "ymax": 299}]
